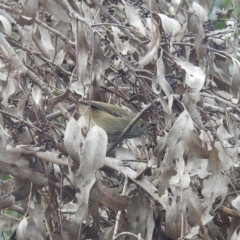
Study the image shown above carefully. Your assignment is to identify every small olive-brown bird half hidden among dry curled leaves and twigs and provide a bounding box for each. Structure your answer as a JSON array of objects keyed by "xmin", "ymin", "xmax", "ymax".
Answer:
[{"xmin": 79, "ymin": 101, "xmax": 146, "ymax": 139}]
